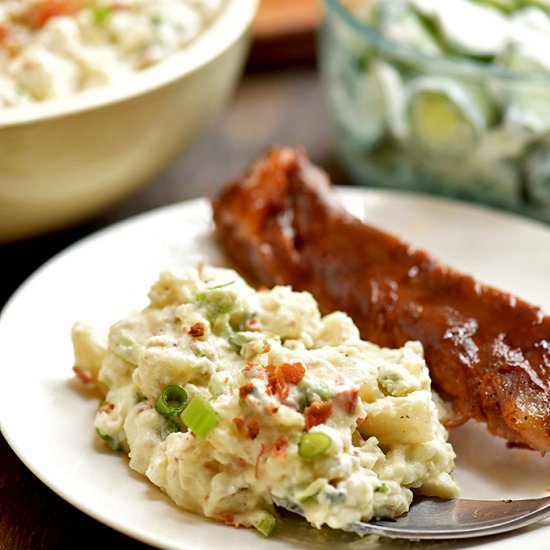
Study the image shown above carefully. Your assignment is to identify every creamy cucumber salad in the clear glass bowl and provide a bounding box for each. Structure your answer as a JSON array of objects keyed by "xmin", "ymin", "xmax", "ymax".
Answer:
[{"xmin": 322, "ymin": 0, "xmax": 550, "ymax": 221}]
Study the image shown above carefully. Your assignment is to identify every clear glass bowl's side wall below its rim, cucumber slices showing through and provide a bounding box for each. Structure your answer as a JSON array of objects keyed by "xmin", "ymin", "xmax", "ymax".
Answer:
[{"xmin": 319, "ymin": 0, "xmax": 550, "ymax": 222}]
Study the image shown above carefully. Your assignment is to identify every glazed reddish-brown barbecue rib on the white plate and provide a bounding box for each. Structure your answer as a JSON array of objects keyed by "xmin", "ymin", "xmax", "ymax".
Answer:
[{"xmin": 213, "ymin": 149, "xmax": 550, "ymax": 452}]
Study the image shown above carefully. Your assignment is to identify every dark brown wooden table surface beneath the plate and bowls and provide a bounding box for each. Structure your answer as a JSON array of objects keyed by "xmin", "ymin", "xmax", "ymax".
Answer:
[{"xmin": 0, "ymin": 66, "xmax": 344, "ymax": 550}]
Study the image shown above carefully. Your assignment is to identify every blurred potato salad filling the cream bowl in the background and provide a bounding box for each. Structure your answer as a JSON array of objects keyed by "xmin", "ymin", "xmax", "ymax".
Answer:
[{"xmin": 0, "ymin": 0, "xmax": 223, "ymax": 107}]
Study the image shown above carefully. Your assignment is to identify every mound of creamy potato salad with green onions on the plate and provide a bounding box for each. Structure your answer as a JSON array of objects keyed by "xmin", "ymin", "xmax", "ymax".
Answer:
[{"xmin": 72, "ymin": 266, "xmax": 458, "ymax": 536}]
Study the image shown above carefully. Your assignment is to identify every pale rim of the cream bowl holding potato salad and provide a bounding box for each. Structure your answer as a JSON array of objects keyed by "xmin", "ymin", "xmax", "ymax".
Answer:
[{"xmin": 0, "ymin": 0, "xmax": 259, "ymax": 129}]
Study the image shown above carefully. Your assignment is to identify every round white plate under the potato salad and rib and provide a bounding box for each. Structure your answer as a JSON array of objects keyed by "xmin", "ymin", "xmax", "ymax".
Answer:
[{"xmin": 0, "ymin": 189, "xmax": 550, "ymax": 550}]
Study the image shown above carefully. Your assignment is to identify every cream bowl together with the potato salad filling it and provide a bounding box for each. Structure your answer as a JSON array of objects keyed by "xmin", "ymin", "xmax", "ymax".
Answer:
[{"xmin": 0, "ymin": 0, "xmax": 257, "ymax": 242}]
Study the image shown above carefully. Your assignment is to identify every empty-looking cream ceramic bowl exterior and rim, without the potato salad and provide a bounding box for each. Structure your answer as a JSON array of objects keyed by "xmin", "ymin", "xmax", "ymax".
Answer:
[{"xmin": 0, "ymin": 0, "xmax": 258, "ymax": 242}]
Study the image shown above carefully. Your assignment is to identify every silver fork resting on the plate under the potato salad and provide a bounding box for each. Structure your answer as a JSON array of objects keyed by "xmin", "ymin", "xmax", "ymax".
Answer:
[{"xmin": 274, "ymin": 496, "xmax": 550, "ymax": 540}]
